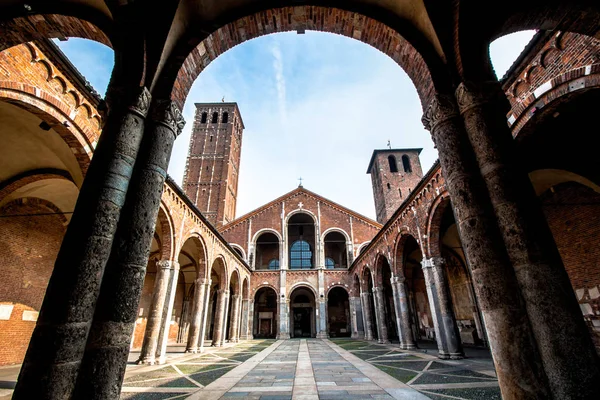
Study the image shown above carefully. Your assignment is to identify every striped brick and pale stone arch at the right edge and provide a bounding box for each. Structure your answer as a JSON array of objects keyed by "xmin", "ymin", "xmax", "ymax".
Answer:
[{"xmin": 510, "ymin": 64, "xmax": 600, "ymax": 138}]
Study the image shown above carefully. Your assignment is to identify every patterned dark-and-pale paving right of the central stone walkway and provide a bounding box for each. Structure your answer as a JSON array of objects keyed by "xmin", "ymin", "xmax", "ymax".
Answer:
[{"xmin": 330, "ymin": 339, "xmax": 502, "ymax": 400}]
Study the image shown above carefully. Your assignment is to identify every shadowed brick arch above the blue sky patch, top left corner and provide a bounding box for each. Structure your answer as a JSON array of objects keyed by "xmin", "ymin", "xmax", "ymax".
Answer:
[{"xmin": 0, "ymin": 13, "xmax": 112, "ymax": 51}]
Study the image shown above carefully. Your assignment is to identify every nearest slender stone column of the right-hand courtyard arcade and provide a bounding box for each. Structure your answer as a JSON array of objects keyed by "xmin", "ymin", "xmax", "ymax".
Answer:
[{"xmin": 429, "ymin": 257, "xmax": 465, "ymax": 360}]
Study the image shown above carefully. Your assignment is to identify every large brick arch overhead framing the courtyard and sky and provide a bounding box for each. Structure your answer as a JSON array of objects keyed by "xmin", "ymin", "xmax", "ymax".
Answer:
[{"xmin": 163, "ymin": 5, "xmax": 441, "ymax": 110}]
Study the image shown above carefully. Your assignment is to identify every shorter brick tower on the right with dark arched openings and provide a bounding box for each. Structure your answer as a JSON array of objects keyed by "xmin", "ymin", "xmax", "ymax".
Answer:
[{"xmin": 367, "ymin": 149, "xmax": 423, "ymax": 224}]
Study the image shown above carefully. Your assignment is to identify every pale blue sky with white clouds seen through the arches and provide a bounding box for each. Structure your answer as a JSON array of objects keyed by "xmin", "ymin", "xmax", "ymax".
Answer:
[{"xmin": 55, "ymin": 31, "xmax": 534, "ymax": 219}]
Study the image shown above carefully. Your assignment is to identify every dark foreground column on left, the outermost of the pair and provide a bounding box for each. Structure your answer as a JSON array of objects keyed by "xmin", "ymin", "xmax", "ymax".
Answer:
[{"xmin": 13, "ymin": 85, "xmax": 150, "ymax": 399}]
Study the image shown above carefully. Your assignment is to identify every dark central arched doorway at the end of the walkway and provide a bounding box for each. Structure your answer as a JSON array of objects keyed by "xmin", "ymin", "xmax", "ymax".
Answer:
[{"xmin": 290, "ymin": 287, "xmax": 317, "ymax": 338}]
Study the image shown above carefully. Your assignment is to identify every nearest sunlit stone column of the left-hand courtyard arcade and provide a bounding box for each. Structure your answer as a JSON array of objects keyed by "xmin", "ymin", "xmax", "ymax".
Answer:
[{"xmin": 137, "ymin": 260, "xmax": 177, "ymax": 365}]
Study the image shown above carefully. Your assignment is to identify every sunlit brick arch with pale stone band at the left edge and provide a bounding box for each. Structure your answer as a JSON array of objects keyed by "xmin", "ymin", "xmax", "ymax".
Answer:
[{"xmin": 0, "ymin": 81, "xmax": 96, "ymax": 175}]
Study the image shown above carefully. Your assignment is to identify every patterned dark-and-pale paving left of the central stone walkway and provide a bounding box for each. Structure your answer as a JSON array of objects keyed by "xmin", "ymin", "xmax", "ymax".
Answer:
[{"xmin": 121, "ymin": 340, "xmax": 275, "ymax": 400}]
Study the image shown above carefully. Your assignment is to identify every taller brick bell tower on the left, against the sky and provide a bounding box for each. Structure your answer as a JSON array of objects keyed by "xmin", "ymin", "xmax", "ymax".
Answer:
[{"xmin": 183, "ymin": 103, "xmax": 244, "ymax": 229}]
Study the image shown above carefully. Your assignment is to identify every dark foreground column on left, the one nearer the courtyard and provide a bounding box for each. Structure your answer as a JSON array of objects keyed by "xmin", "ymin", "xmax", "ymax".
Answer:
[{"xmin": 71, "ymin": 100, "xmax": 185, "ymax": 398}]
